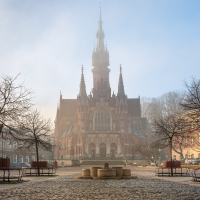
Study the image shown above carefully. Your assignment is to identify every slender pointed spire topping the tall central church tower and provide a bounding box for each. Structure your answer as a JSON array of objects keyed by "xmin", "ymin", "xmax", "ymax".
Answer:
[{"xmin": 96, "ymin": 6, "xmax": 105, "ymax": 52}]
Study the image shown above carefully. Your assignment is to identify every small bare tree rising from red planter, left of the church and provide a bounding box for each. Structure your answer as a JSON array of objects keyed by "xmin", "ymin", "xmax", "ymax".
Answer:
[{"xmin": 12, "ymin": 110, "xmax": 53, "ymax": 175}]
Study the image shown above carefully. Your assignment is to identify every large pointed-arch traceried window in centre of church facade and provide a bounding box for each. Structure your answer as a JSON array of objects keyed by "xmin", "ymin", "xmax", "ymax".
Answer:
[{"xmin": 95, "ymin": 107, "xmax": 110, "ymax": 131}]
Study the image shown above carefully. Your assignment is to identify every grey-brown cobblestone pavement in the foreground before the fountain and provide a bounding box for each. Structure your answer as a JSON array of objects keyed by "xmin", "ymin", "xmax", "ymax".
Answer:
[{"xmin": 0, "ymin": 174, "xmax": 200, "ymax": 200}]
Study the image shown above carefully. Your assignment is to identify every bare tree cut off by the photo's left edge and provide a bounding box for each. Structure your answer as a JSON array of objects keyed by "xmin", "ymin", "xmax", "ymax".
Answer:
[{"xmin": 0, "ymin": 75, "xmax": 33, "ymax": 137}]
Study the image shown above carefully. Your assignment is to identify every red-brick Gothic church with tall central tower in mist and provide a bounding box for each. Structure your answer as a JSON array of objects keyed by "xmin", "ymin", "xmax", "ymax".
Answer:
[{"xmin": 54, "ymin": 10, "xmax": 151, "ymax": 160}]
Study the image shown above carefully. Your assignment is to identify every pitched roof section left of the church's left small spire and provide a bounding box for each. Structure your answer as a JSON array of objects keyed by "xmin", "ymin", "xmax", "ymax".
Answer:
[{"xmin": 60, "ymin": 99, "xmax": 77, "ymax": 117}]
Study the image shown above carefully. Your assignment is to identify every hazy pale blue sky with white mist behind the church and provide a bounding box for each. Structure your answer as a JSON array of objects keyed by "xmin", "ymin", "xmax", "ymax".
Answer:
[{"xmin": 0, "ymin": 0, "xmax": 200, "ymax": 119}]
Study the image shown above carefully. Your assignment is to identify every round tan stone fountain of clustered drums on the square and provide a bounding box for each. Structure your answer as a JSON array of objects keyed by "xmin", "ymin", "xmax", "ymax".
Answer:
[{"xmin": 76, "ymin": 163, "xmax": 137, "ymax": 179}]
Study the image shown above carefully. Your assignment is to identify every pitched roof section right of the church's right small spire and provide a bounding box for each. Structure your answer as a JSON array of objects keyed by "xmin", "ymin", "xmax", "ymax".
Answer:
[{"xmin": 127, "ymin": 98, "xmax": 141, "ymax": 117}]
